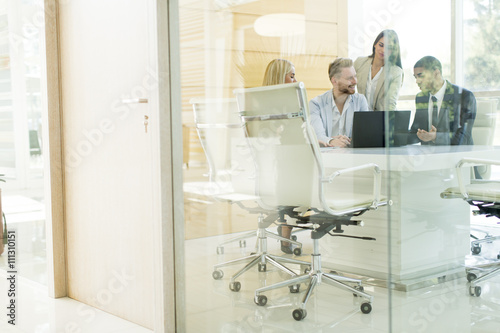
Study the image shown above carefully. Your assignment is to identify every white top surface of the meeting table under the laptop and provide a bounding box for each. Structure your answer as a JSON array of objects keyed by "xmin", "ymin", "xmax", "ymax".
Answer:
[{"xmin": 321, "ymin": 145, "xmax": 500, "ymax": 171}]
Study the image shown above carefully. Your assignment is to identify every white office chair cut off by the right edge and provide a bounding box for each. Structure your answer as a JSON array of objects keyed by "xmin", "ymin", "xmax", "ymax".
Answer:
[{"xmin": 441, "ymin": 158, "xmax": 500, "ymax": 297}]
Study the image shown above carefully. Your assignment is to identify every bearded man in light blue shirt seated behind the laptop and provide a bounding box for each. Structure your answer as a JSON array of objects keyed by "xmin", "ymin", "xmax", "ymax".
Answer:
[{"xmin": 309, "ymin": 58, "xmax": 369, "ymax": 147}]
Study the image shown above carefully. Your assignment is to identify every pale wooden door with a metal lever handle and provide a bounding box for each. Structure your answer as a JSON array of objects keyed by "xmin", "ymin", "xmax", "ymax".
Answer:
[{"xmin": 59, "ymin": 0, "xmax": 158, "ymax": 328}]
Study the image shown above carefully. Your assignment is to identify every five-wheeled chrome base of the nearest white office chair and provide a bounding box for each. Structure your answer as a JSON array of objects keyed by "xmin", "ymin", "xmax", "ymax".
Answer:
[{"xmin": 254, "ymin": 239, "xmax": 373, "ymax": 321}]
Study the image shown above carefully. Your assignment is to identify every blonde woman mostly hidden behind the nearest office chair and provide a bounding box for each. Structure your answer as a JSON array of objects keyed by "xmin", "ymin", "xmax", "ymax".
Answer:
[{"xmin": 262, "ymin": 59, "xmax": 297, "ymax": 254}]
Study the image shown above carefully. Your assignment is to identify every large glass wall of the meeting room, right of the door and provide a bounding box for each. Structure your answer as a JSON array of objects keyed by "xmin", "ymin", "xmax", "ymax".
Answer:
[{"xmin": 179, "ymin": 0, "xmax": 500, "ymax": 332}]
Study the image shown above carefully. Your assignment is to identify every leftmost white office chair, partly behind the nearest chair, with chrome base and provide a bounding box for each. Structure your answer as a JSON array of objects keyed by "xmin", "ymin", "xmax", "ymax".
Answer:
[{"xmin": 191, "ymin": 99, "xmax": 309, "ymax": 291}]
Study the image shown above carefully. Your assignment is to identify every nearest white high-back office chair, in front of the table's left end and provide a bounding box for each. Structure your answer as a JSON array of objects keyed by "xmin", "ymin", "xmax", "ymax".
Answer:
[{"xmin": 235, "ymin": 82, "xmax": 387, "ymax": 320}]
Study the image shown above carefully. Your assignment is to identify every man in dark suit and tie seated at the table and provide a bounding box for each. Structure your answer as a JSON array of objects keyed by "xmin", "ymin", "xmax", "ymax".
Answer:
[{"xmin": 409, "ymin": 56, "xmax": 476, "ymax": 145}]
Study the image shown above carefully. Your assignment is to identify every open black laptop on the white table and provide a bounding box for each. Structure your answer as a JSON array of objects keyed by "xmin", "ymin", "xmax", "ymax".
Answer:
[{"xmin": 351, "ymin": 110, "xmax": 411, "ymax": 148}]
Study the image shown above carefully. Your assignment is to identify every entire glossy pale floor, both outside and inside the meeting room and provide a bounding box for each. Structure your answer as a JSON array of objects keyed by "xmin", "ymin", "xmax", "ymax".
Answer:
[{"xmin": 0, "ymin": 215, "xmax": 500, "ymax": 333}]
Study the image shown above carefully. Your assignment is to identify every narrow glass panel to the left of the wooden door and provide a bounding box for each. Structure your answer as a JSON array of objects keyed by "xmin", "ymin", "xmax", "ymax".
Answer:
[{"xmin": 0, "ymin": 0, "xmax": 47, "ymax": 284}]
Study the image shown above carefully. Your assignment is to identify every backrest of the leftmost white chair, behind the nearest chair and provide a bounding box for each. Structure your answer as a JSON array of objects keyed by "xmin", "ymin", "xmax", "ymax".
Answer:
[{"xmin": 191, "ymin": 98, "xmax": 255, "ymax": 195}]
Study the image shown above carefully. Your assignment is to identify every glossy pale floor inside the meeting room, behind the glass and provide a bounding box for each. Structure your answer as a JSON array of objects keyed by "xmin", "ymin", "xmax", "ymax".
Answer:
[{"xmin": 186, "ymin": 220, "xmax": 500, "ymax": 333}]
